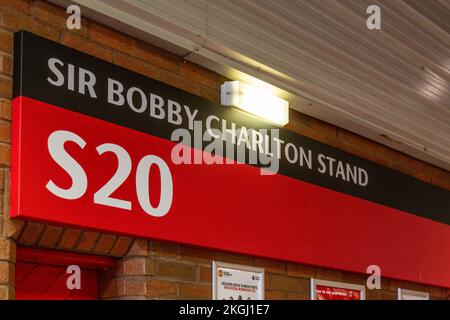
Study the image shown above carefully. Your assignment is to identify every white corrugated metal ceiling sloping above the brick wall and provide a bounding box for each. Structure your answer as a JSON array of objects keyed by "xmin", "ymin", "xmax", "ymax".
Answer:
[{"xmin": 50, "ymin": 0, "xmax": 450, "ymax": 170}]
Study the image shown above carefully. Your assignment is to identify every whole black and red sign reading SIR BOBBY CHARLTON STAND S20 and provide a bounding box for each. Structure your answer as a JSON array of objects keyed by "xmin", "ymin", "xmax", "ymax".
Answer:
[{"xmin": 11, "ymin": 32, "xmax": 450, "ymax": 286}]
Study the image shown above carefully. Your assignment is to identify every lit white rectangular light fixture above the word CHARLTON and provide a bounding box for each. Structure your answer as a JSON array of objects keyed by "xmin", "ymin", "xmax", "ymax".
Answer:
[{"xmin": 220, "ymin": 81, "xmax": 289, "ymax": 126}]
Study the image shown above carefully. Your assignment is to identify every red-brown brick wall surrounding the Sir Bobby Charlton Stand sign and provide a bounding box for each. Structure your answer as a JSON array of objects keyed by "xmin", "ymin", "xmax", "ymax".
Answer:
[{"xmin": 0, "ymin": 0, "xmax": 450, "ymax": 299}]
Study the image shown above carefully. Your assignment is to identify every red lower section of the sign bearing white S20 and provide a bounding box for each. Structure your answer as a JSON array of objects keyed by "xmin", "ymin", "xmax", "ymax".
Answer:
[{"xmin": 11, "ymin": 97, "xmax": 450, "ymax": 286}]
